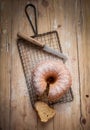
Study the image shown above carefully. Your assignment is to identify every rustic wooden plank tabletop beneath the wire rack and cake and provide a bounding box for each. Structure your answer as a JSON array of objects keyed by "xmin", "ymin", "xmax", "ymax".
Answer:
[{"xmin": 0, "ymin": 0, "xmax": 90, "ymax": 130}]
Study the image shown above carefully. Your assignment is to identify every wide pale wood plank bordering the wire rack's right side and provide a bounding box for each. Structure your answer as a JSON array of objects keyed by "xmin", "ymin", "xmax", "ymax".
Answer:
[{"xmin": 52, "ymin": 0, "xmax": 81, "ymax": 130}]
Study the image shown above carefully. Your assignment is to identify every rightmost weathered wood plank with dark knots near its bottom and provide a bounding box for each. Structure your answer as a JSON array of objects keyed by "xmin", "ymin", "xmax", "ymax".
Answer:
[{"xmin": 77, "ymin": 0, "xmax": 90, "ymax": 130}]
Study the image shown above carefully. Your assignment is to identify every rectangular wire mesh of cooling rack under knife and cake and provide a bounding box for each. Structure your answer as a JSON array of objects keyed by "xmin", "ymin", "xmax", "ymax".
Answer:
[{"xmin": 17, "ymin": 31, "xmax": 73, "ymax": 106}]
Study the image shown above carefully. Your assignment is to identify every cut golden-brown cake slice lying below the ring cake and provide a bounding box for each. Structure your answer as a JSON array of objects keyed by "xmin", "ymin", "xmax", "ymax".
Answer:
[{"xmin": 35, "ymin": 101, "xmax": 56, "ymax": 122}]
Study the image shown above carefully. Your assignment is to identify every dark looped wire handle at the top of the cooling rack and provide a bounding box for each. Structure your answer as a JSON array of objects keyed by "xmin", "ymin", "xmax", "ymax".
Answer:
[{"xmin": 25, "ymin": 4, "xmax": 38, "ymax": 36}]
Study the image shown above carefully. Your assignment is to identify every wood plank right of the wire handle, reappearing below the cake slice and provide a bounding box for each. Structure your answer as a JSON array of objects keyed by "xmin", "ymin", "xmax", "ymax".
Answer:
[{"xmin": 37, "ymin": 0, "xmax": 53, "ymax": 130}]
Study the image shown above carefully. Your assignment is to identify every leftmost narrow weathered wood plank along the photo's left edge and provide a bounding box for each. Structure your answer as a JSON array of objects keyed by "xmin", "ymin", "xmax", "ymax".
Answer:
[{"xmin": 0, "ymin": 0, "xmax": 11, "ymax": 130}]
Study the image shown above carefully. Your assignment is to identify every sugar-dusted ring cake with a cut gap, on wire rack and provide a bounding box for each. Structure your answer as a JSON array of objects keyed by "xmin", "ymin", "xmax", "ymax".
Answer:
[{"xmin": 32, "ymin": 60, "xmax": 72, "ymax": 101}]
